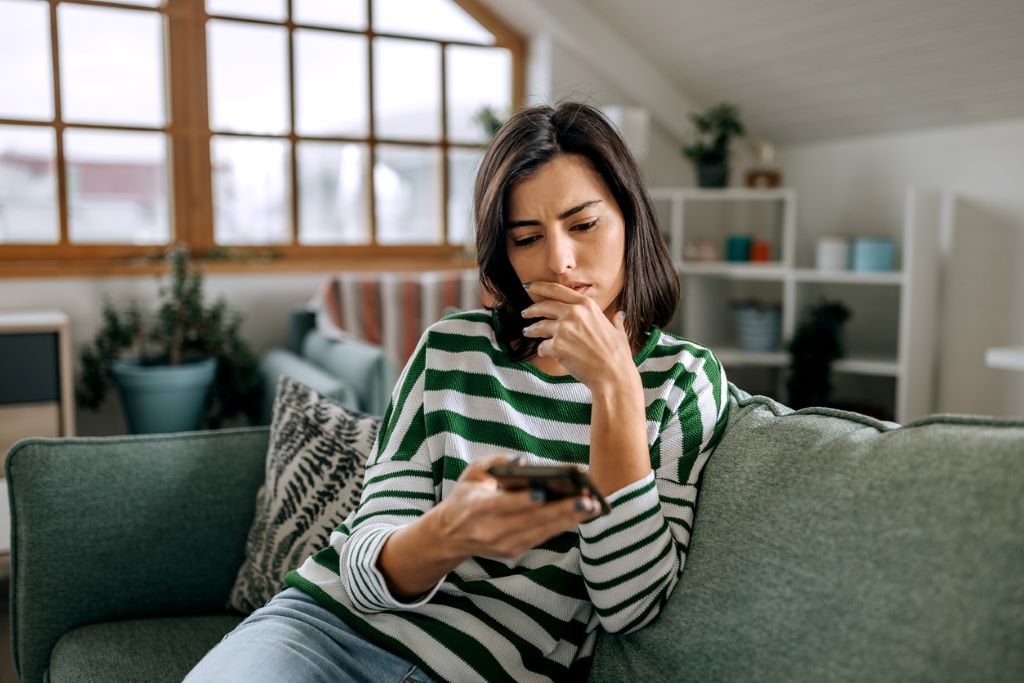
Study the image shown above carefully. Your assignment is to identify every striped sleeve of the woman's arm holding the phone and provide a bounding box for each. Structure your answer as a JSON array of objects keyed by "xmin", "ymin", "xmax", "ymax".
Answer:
[{"xmin": 332, "ymin": 333, "xmax": 441, "ymax": 613}]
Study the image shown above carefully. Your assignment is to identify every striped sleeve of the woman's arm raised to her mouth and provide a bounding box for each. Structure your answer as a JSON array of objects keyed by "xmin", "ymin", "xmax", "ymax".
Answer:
[{"xmin": 580, "ymin": 345, "xmax": 728, "ymax": 633}]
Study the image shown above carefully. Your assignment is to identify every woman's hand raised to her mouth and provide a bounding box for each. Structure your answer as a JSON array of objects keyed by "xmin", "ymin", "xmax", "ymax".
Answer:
[{"xmin": 522, "ymin": 281, "xmax": 636, "ymax": 390}]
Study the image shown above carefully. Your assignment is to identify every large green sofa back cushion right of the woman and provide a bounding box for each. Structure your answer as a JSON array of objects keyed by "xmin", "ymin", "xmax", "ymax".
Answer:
[{"xmin": 593, "ymin": 387, "xmax": 1024, "ymax": 681}]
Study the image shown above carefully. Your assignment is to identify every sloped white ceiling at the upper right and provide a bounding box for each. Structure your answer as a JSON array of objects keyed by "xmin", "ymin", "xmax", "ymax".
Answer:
[{"xmin": 577, "ymin": 0, "xmax": 1024, "ymax": 144}]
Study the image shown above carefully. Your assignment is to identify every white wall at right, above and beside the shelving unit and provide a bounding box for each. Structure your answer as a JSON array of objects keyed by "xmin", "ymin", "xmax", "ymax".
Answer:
[{"xmin": 779, "ymin": 120, "xmax": 1024, "ymax": 416}]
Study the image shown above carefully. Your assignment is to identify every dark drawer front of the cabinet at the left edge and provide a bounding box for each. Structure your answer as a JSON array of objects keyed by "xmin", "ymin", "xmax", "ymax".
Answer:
[{"xmin": 0, "ymin": 332, "xmax": 60, "ymax": 405}]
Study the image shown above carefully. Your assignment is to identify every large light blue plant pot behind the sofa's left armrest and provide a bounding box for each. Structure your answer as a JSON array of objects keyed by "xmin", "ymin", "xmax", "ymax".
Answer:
[{"xmin": 111, "ymin": 358, "xmax": 217, "ymax": 434}]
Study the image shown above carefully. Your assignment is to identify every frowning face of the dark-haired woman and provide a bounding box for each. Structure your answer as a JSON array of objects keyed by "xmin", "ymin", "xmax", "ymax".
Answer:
[{"xmin": 505, "ymin": 155, "xmax": 626, "ymax": 319}]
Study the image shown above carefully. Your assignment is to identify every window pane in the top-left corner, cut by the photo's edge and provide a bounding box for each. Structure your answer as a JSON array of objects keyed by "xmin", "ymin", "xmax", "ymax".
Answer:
[{"xmin": 0, "ymin": 0, "xmax": 53, "ymax": 121}]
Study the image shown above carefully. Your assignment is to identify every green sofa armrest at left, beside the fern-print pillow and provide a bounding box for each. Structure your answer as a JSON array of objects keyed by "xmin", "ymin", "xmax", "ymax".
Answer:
[{"xmin": 5, "ymin": 427, "xmax": 268, "ymax": 683}]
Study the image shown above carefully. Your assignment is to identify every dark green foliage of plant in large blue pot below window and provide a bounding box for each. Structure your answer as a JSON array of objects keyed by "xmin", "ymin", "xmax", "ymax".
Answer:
[{"xmin": 75, "ymin": 245, "xmax": 262, "ymax": 428}]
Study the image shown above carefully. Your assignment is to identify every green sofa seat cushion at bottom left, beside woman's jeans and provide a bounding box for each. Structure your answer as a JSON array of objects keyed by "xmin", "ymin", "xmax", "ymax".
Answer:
[{"xmin": 48, "ymin": 615, "xmax": 242, "ymax": 683}]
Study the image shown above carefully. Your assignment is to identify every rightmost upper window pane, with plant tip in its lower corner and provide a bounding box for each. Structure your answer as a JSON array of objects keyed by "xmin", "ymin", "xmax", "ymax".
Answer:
[{"xmin": 444, "ymin": 45, "xmax": 512, "ymax": 142}]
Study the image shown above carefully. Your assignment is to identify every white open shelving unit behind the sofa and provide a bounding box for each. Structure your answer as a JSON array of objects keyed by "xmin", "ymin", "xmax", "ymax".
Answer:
[{"xmin": 651, "ymin": 187, "xmax": 952, "ymax": 422}]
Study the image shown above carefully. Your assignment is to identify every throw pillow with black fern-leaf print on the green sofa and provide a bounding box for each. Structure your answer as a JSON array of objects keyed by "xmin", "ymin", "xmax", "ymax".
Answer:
[{"xmin": 228, "ymin": 376, "xmax": 380, "ymax": 614}]
